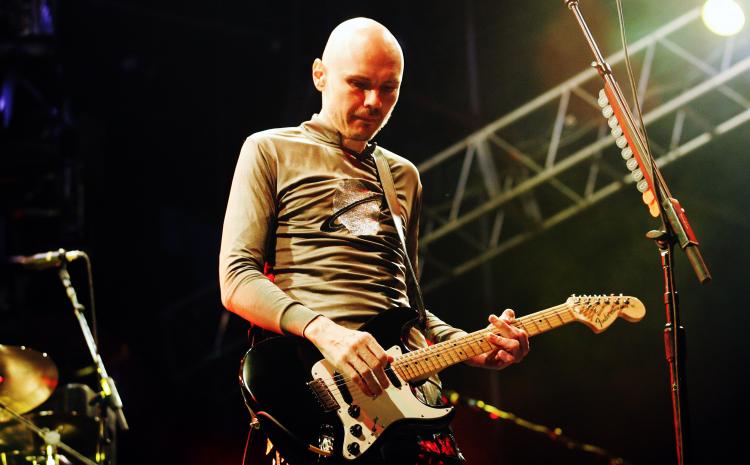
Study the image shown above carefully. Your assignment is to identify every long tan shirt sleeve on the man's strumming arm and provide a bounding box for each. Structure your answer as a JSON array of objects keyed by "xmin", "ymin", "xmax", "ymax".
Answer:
[{"xmin": 219, "ymin": 136, "xmax": 318, "ymax": 336}]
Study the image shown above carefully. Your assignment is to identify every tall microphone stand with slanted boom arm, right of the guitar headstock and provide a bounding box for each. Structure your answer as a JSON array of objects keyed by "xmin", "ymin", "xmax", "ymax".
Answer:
[{"xmin": 564, "ymin": 0, "xmax": 711, "ymax": 465}]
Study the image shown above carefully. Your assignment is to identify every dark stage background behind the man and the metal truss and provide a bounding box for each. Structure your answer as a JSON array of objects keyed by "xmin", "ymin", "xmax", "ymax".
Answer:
[{"xmin": 0, "ymin": 0, "xmax": 750, "ymax": 464}]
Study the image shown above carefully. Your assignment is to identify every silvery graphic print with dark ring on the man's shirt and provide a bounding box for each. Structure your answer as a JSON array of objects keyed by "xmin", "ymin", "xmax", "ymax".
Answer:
[{"xmin": 320, "ymin": 179, "xmax": 383, "ymax": 236}]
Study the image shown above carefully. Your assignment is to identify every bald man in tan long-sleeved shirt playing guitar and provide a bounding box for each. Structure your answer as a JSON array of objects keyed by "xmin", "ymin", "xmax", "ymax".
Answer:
[{"xmin": 219, "ymin": 18, "xmax": 529, "ymax": 463}]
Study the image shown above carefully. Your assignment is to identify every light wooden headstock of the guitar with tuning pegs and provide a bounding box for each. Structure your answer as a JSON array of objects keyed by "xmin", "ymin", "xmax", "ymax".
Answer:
[{"xmin": 565, "ymin": 294, "xmax": 646, "ymax": 334}]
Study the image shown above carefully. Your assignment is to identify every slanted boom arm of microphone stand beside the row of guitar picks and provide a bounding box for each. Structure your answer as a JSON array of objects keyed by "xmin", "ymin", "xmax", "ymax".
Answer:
[{"xmin": 565, "ymin": 0, "xmax": 711, "ymax": 284}]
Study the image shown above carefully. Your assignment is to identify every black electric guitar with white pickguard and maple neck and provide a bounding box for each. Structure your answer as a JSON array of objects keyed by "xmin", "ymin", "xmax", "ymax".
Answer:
[{"xmin": 240, "ymin": 295, "xmax": 646, "ymax": 464}]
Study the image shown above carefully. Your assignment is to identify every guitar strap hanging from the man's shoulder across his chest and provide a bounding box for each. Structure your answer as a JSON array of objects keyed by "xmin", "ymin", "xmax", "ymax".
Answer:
[{"xmin": 372, "ymin": 147, "xmax": 427, "ymax": 332}]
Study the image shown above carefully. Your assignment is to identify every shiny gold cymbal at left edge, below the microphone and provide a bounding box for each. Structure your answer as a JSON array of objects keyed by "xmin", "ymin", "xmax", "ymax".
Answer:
[{"xmin": 0, "ymin": 344, "xmax": 57, "ymax": 421}]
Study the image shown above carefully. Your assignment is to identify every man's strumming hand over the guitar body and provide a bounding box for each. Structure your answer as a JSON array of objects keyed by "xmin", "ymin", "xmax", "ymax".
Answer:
[{"xmin": 304, "ymin": 316, "xmax": 393, "ymax": 397}]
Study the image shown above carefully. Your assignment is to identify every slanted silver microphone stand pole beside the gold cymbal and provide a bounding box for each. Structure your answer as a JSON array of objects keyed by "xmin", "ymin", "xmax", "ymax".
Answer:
[{"xmin": 58, "ymin": 249, "xmax": 129, "ymax": 431}]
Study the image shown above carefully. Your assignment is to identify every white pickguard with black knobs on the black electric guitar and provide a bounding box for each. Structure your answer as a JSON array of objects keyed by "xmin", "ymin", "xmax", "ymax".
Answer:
[{"xmin": 311, "ymin": 346, "xmax": 453, "ymax": 460}]
